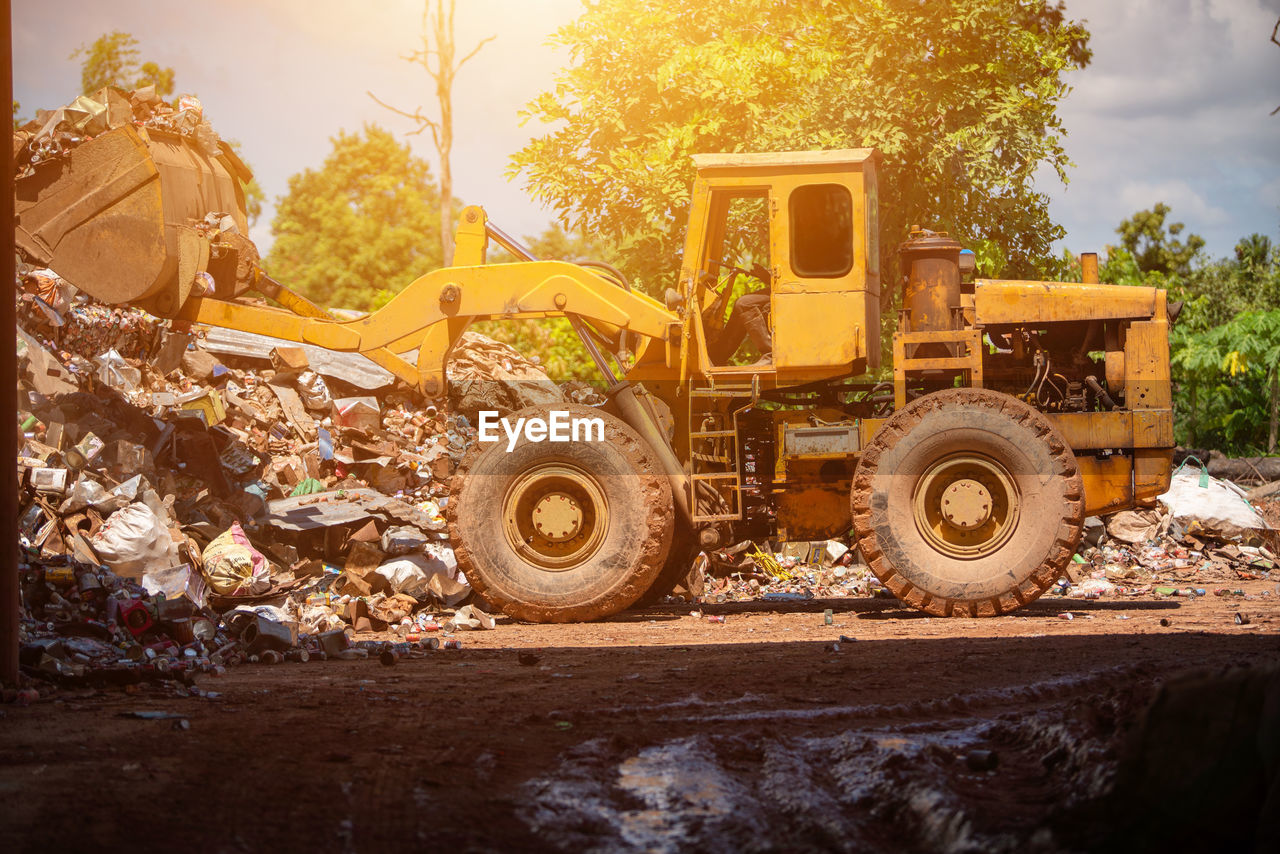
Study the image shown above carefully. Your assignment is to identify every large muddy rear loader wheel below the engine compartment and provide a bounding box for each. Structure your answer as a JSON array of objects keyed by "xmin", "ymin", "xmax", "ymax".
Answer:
[{"xmin": 850, "ymin": 388, "xmax": 1084, "ymax": 617}]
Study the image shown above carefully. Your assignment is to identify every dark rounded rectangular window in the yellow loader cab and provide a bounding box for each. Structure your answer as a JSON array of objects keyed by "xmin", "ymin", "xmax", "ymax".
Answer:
[{"xmin": 790, "ymin": 184, "xmax": 854, "ymax": 279}]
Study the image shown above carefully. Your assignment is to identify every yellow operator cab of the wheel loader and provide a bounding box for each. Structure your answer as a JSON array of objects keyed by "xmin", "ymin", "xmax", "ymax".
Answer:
[{"xmin": 681, "ymin": 149, "xmax": 879, "ymax": 382}]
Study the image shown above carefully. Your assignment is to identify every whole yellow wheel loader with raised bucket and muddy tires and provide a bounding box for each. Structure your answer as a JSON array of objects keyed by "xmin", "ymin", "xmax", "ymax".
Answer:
[{"xmin": 15, "ymin": 125, "xmax": 1174, "ymax": 621}]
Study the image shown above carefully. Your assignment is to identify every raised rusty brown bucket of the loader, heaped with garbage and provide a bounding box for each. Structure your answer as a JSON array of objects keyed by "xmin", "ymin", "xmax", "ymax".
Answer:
[{"xmin": 15, "ymin": 125, "xmax": 248, "ymax": 316}]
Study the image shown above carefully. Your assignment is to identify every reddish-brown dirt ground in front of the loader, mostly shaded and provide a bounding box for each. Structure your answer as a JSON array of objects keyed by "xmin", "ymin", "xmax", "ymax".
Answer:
[{"xmin": 0, "ymin": 581, "xmax": 1280, "ymax": 853}]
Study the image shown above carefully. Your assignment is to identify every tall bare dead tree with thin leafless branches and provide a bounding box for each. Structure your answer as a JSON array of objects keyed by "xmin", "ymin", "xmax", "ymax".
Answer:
[{"xmin": 366, "ymin": 0, "xmax": 495, "ymax": 264}]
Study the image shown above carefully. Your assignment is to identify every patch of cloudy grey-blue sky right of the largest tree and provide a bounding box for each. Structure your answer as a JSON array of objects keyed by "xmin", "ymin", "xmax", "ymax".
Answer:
[{"xmin": 1041, "ymin": 0, "xmax": 1280, "ymax": 256}]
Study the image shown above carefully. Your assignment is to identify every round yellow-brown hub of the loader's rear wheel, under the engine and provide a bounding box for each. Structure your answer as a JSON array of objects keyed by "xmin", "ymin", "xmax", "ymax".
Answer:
[{"xmin": 911, "ymin": 453, "xmax": 1020, "ymax": 560}]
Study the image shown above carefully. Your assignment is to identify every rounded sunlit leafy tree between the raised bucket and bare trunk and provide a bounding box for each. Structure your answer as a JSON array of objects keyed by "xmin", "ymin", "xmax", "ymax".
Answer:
[{"xmin": 265, "ymin": 124, "xmax": 442, "ymax": 310}]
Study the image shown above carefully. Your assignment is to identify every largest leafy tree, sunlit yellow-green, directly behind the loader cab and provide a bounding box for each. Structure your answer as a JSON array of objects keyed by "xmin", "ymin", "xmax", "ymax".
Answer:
[{"xmin": 511, "ymin": 0, "xmax": 1091, "ymax": 292}]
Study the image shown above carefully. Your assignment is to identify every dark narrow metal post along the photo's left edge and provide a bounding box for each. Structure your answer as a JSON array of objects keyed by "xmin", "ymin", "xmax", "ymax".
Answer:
[{"xmin": 0, "ymin": 0, "xmax": 18, "ymax": 685}]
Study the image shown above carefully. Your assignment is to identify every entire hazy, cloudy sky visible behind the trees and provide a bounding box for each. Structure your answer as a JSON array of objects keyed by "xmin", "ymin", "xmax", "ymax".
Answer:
[{"xmin": 13, "ymin": 0, "xmax": 1280, "ymax": 262}]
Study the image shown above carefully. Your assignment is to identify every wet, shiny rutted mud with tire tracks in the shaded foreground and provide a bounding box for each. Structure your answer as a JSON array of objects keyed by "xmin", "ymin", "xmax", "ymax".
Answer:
[{"xmin": 518, "ymin": 667, "xmax": 1151, "ymax": 851}]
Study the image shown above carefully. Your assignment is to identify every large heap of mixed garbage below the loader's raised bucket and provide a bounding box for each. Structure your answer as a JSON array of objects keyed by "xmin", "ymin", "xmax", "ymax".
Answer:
[{"xmin": 17, "ymin": 277, "xmax": 573, "ymax": 682}]
